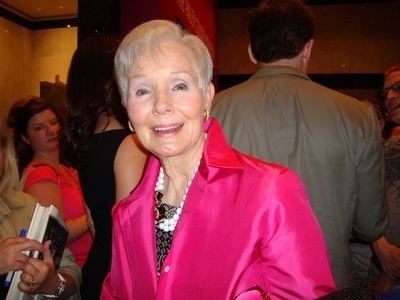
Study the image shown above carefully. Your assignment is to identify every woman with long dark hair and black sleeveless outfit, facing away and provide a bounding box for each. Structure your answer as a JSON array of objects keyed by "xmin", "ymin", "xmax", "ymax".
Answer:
[{"xmin": 67, "ymin": 36, "xmax": 146, "ymax": 299}]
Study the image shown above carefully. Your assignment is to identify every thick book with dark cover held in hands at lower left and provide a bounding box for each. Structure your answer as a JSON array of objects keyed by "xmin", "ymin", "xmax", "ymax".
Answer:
[{"xmin": 6, "ymin": 203, "xmax": 68, "ymax": 300}]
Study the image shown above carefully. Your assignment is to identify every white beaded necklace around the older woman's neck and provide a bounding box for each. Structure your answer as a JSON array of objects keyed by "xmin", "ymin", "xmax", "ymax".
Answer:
[{"xmin": 154, "ymin": 161, "xmax": 200, "ymax": 232}]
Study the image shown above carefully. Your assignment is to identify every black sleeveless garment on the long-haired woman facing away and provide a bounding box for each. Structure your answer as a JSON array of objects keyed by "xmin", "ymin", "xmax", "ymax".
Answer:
[{"xmin": 78, "ymin": 129, "xmax": 130, "ymax": 299}]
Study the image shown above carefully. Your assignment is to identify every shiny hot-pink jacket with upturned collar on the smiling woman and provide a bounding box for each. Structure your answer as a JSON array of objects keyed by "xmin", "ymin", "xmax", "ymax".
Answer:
[{"xmin": 101, "ymin": 120, "xmax": 335, "ymax": 300}]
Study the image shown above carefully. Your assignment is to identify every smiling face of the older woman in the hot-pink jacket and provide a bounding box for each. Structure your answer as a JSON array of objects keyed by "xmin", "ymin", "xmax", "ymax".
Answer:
[{"xmin": 124, "ymin": 42, "xmax": 214, "ymax": 159}]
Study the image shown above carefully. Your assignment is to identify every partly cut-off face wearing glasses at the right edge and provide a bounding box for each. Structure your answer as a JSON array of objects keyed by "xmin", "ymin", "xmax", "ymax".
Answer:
[{"xmin": 383, "ymin": 70, "xmax": 400, "ymax": 124}]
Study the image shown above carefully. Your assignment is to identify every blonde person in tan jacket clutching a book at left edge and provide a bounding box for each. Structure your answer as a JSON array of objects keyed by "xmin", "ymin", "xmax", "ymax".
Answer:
[{"xmin": 0, "ymin": 123, "xmax": 81, "ymax": 299}]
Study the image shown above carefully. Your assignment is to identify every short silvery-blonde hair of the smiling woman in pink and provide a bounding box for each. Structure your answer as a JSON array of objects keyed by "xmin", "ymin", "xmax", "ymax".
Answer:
[{"xmin": 114, "ymin": 20, "xmax": 213, "ymax": 101}]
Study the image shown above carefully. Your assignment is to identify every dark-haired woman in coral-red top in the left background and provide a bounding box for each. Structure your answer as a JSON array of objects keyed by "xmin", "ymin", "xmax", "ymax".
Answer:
[{"xmin": 7, "ymin": 96, "xmax": 92, "ymax": 267}]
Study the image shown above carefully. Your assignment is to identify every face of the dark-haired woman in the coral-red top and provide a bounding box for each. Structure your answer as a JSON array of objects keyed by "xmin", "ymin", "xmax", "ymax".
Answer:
[{"xmin": 22, "ymin": 109, "xmax": 60, "ymax": 153}]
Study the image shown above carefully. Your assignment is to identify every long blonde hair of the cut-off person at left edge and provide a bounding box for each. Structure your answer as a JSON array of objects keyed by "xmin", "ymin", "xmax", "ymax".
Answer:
[{"xmin": 0, "ymin": 121, "xmax": 19, "ymax": 194}]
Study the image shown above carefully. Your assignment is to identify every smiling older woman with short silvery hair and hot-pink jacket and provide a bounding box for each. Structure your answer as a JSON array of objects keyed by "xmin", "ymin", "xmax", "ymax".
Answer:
[{"xmin": 102, "ymin": 20, "xmax": 335, "ymax": 300}]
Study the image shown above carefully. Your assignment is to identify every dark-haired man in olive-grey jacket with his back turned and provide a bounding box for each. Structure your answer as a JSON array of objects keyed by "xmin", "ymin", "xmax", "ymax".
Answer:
[{"xmin": 212, "ymin": 0, "xmax": 387, "ymax": 288}]
